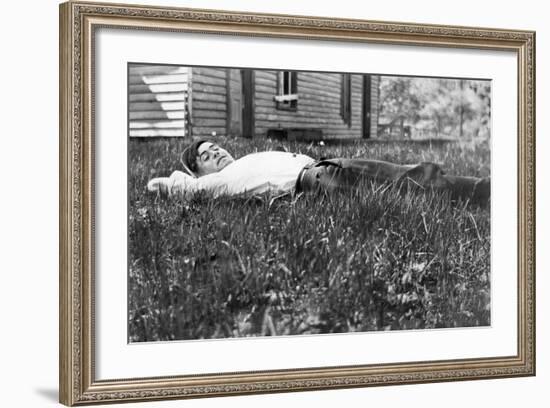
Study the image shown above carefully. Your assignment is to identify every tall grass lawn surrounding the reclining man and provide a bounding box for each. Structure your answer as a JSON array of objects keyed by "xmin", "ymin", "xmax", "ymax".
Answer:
[{"xmin": 128, "ymin": 139, "xmax": 490, "ymax": 342}]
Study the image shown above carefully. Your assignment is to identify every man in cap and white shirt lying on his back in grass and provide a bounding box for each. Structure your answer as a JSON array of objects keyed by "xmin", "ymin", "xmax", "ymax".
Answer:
[{"xmin": 147, "ymin": 140, "xmax": 491, "ymax": 204}]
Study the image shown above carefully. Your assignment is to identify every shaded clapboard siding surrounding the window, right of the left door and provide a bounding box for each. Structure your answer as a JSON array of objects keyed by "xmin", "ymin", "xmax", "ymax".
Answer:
[{"xmin": 255, "ymin": 71, "xmax": 363, "ymax": 138}]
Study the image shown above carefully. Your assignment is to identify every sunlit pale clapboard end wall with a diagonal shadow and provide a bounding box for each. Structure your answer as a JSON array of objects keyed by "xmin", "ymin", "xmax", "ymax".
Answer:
[{"xmin": 128, "ymin": 65, "xmax": 189, "ymax": 137}]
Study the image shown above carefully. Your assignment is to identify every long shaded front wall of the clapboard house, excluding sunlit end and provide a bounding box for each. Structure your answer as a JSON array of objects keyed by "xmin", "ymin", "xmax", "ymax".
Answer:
[{"xmin": 190, "ymin": 67, "xmax": 379, "ymax": 139}]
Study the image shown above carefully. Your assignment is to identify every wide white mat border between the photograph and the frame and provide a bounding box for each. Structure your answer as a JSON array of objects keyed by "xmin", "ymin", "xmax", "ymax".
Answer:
[{"xmin": 95, "ymin": 28, "xmax": 518, "ymax": 379}]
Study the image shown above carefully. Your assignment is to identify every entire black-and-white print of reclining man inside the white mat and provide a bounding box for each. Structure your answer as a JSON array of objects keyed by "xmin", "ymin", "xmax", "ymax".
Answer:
[{"xmin": 127, "ymin": 62, "xmax": 492, "ymax": 343}]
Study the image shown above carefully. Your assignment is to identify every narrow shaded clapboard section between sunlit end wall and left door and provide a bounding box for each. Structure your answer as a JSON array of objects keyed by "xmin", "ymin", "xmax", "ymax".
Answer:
[{"xmin": 191, "ymin": 67, "xmax": 228, "ymax": 137}]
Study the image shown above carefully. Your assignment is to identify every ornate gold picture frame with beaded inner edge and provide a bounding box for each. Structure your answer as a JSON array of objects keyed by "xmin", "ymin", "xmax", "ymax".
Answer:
[{"xmin": 59, "ymin": 2, "xmax": 535, "ymax": 406}]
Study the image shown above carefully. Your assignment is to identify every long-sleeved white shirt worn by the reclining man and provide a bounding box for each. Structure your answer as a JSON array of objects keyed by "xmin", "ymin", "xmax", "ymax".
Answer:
[{"xmin": 167, "ymin": 152, "xmax": 314, "ymax": 197}]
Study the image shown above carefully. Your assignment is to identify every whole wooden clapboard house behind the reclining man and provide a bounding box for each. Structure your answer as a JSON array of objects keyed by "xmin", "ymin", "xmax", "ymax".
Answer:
[{"xmin": 129, "ymin": 65, "xmax": 379, "ymax": 140}]
